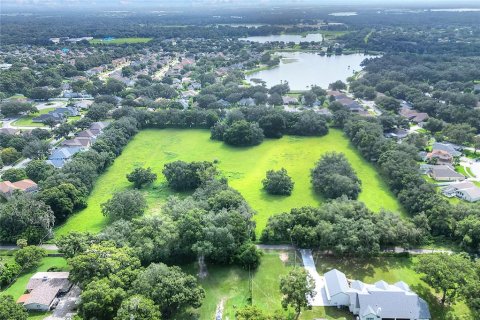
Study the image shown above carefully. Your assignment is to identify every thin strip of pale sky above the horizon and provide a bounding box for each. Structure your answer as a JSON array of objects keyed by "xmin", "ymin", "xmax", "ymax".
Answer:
[{"xmin": 0, "ymin": 0, "xmax": 480, "ymax": 10}]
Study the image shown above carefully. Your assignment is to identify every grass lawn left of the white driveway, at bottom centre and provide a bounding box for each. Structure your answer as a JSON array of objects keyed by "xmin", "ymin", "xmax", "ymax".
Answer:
[{"xmin": 186, "ymin": 251, "xmax": 349, "ymax": 320}]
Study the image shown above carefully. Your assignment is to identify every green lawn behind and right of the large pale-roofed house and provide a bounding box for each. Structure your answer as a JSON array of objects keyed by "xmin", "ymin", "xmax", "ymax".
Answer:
[{"xmin": 315, "ymin": 256, "xmax": 473, "ymax": 320}]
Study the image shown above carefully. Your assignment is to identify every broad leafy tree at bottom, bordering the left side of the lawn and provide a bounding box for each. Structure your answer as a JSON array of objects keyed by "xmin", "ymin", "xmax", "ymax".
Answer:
[{"xmin": 132, "ymin": 263, "xmax": 205, "ymax": 318}]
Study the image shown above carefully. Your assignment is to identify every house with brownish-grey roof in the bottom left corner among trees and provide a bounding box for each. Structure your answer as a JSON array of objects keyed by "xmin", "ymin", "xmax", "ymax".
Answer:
[{"xmin": 17, "ymin": 272, "xmax": 72, "ymax": 311}]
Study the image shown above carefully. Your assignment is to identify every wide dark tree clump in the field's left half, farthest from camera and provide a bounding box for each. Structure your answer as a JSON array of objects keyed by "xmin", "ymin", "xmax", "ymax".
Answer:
[{"xmin": 162, "ymin": 160, "xmax": 217, "ymax": 191}]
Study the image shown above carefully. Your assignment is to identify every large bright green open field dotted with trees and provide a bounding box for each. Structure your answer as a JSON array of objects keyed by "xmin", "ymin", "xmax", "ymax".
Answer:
[{"xmin": 56, "ymin": 129, "xmax": 402, "ymax": 236}]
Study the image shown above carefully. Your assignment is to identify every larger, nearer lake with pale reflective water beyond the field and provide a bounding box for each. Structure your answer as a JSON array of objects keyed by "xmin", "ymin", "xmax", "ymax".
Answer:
[{"xmin": 247, "ymin": 52, "xmax": 373, "ymax": 90}]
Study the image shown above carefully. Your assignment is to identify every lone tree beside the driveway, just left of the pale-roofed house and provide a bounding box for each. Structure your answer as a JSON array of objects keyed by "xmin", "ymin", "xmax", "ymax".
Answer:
[{"xmin": 280, "ymin": 268, "xmax": 315, "ymax": 319}]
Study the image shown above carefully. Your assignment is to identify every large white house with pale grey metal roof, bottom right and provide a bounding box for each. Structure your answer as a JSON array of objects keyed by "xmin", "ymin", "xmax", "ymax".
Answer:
[{"xmin": 324, "ymin": 269, "xmax": 431, "ymax": 320}]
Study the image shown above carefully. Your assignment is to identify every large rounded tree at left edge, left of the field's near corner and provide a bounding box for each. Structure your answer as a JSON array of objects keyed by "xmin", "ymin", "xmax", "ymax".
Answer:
[{"xmin": 0, "ymin": 194, "xmax": 55, "ymax": 243}]
